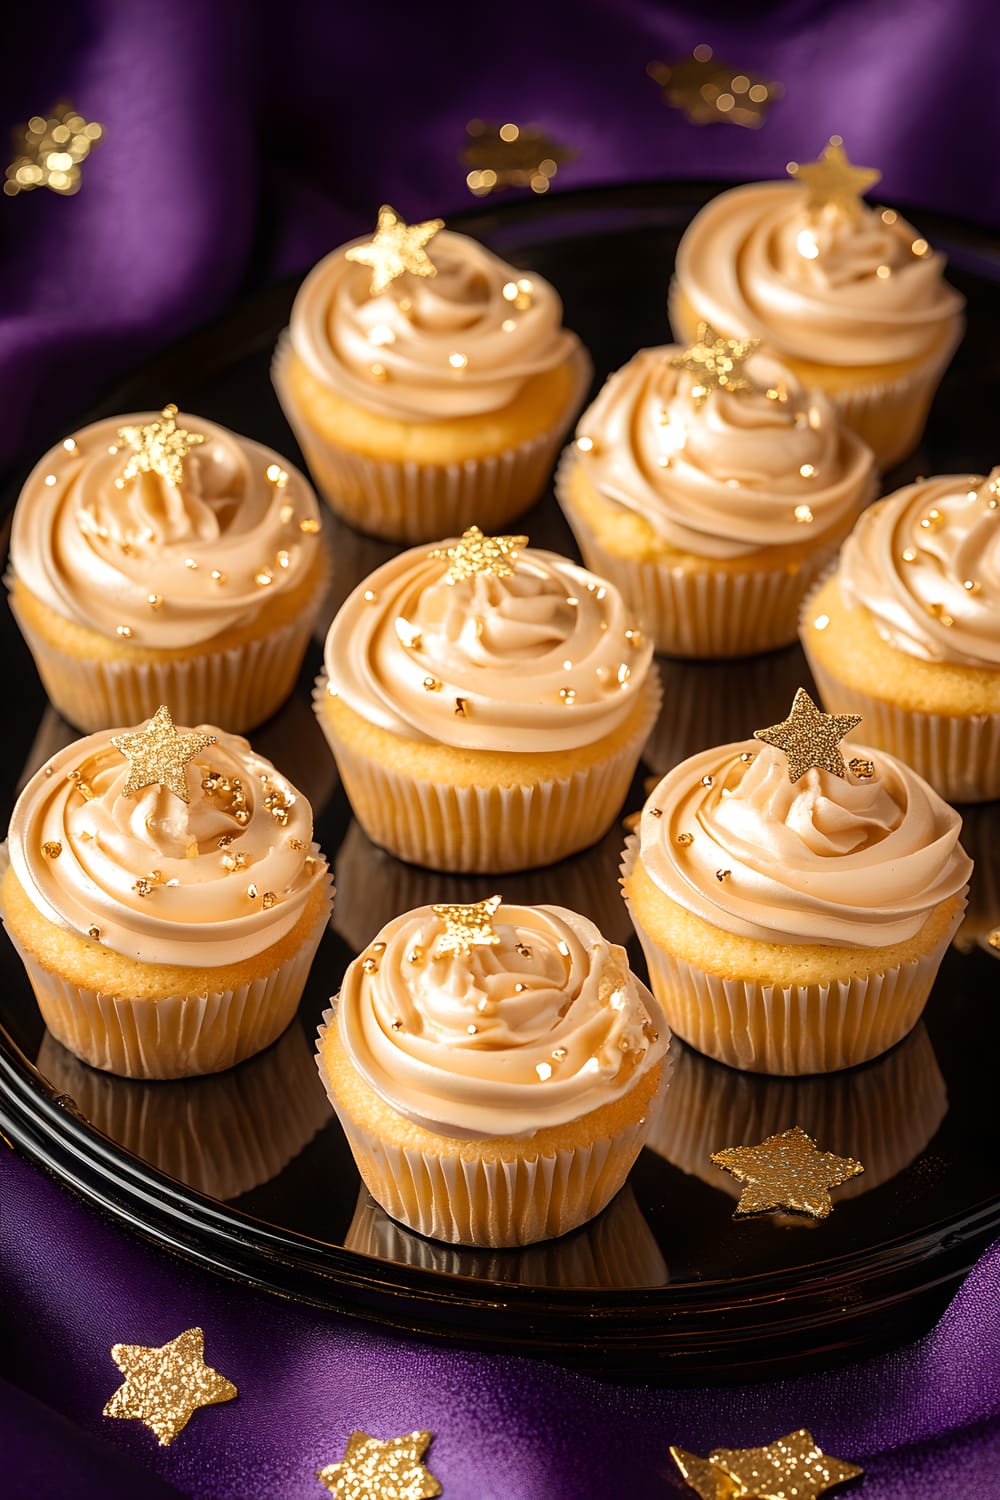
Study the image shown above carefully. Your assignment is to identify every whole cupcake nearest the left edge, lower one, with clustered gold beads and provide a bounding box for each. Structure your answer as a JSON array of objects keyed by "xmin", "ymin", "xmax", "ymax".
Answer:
[{"xmin": 0, "ymin": 708, "xmax": 330, "ymax": 1079}]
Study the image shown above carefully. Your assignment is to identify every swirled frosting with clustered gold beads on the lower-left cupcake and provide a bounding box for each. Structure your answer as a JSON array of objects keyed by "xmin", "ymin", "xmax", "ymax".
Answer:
[{"xmin": 7, "ymin": 725, "xmax": 327, "ymax": 968}]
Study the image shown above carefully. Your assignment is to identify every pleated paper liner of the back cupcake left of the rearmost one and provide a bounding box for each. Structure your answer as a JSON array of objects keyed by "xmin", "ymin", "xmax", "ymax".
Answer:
[{"xmin": 271, "ymin": 330, "xmax": 592, "ymax": 543}]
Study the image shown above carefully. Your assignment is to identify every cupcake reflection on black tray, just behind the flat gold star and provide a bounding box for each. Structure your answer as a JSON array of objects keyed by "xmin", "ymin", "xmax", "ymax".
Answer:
[{"xmin": 646, "ymin": 1022, "xmax": 948, "ymax": 1202}]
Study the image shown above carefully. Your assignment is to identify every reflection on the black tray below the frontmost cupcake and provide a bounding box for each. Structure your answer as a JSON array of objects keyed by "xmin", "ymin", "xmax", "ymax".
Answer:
[{"xmin": 343, "ymin": 1184, "xmax": 670, "ymax": 1289}]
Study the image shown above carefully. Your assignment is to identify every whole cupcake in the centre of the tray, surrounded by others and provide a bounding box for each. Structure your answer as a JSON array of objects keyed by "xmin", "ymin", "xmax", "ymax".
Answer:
[{"xmin": 315, "ymin": 527, "xmax": 660, "ymax": 873}]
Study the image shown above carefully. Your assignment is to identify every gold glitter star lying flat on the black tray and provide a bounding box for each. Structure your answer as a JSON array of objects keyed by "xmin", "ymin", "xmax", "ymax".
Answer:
[{"xmin": 712, "ymin": 1125, "xmax": 865, "ymax": 1218}]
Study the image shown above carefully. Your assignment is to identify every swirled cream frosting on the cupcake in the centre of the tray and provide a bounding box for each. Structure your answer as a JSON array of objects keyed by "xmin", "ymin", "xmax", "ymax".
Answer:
[{"xmin": 324, "ymin": 542, "xmax": 652, "ymax": 752}]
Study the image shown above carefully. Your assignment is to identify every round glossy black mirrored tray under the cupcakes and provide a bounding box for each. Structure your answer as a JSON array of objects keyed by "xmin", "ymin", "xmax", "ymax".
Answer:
[{"xmin": 0, "ymin": 185, "xmax": 1000, "ymax": 1380}]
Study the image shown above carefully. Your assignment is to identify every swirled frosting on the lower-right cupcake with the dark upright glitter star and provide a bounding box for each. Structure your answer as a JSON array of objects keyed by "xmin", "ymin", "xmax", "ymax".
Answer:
[{"xmin": 640, "ymin": 740, "xmax": 972, "ymax": 948}]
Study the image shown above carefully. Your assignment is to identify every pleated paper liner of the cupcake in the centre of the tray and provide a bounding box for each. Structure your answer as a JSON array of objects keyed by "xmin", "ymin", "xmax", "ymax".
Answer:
[{"xmin": 313, "ymin": 665, "xmax": 660, "ymax": 875}]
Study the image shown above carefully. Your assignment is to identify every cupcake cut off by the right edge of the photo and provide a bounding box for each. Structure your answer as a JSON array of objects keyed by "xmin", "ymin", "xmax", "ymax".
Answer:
[{"xmin": 801, "ymin": 468, "xmax": 1000, "ymax": 803}]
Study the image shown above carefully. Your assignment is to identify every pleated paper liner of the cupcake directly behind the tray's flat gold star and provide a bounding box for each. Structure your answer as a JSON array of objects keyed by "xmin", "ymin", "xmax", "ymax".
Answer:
[{"xmin": 622, "ymin": 834, "xmax": 966, "ymax": 1076}]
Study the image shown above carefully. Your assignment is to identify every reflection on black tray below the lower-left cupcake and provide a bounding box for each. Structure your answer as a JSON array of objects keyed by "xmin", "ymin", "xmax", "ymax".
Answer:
[{"xmin": 36, "ymin": 1020, "xmax": 330, "ymax": 1202}]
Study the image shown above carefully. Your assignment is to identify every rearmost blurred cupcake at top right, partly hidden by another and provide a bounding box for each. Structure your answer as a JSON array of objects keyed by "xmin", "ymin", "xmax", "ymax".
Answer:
[{"xmin": 670, "ymin": 137, "xmax": 964, "ymax": 470}]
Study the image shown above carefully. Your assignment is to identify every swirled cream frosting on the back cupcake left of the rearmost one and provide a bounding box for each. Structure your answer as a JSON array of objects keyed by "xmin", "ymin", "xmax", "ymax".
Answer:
[{"xmin": 291, "ymin": 230, "xmax": 580, "ymax": 422}]
